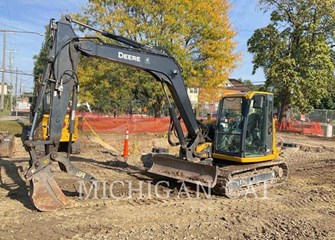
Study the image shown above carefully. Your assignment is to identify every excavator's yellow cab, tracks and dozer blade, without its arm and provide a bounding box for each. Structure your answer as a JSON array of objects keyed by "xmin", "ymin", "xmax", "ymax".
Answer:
[{"xmin": 148, "ymin": 91, "xmax": 288, "ymax": 198}]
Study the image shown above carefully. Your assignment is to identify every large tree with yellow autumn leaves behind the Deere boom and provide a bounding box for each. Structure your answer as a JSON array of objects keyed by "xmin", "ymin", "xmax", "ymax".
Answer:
[{"xmin": 75, "ymin": 0, "xmax": 238, "ymax": 115}]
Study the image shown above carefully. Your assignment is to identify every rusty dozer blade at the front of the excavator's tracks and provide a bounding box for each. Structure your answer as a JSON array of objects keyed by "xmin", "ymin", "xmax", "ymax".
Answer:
[{"xmin": 148, "ymin": 154, "xmax": 219, "ymax": 188}]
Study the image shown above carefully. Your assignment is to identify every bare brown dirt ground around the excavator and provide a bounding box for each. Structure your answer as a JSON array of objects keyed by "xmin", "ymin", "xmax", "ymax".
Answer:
[{"xmin": 0, "ymin": 134, "xmax": 335, "ymax": 239}]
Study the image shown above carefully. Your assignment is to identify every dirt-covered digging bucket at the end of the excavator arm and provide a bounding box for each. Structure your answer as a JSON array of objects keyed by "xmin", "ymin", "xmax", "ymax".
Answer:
[{"xmin": 30, "ymin": 165, "xmax": 71, "ymax": 212}]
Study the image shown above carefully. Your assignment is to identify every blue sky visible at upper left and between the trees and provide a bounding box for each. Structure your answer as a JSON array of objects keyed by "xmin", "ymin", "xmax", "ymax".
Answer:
[{"xmin": 0, "ymin": 0, "xmax": 270, "ymax": 92}]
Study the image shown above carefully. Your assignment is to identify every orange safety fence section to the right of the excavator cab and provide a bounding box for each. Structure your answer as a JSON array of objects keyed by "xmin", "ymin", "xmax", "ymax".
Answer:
[{"xmin": 276, "ymin": 119, "xmax": 323, "ymax": 136}]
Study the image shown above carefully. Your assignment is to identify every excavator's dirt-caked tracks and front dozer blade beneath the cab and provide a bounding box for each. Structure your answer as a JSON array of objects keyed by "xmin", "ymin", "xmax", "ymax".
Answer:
[{"xmin": 148, "ymin": 154, "xmax": 288, "ymax": 198}]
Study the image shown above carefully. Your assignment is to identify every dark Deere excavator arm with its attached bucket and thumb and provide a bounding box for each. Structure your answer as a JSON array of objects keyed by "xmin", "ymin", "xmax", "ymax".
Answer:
[{"xmin": 25, "ymin": 16, "xmax": 216, "ymax": 211}]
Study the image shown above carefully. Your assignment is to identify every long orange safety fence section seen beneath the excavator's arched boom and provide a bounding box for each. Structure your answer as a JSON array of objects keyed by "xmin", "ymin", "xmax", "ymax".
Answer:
[{"xmin": 79, "ymin": 114, "xmax": 185, "ymax": 134}]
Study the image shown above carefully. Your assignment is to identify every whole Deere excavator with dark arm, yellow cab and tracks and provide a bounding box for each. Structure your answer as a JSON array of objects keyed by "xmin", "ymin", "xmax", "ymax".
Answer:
[{"xmin": 24, "ymin": 16, "xmax": 288, "ymax": 211}]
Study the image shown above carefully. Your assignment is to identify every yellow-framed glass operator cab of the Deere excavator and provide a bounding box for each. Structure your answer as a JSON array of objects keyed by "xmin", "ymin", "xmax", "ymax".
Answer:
[{"xmin": 213, "ymin": 92, "xmax": 276, "ymax": 162}]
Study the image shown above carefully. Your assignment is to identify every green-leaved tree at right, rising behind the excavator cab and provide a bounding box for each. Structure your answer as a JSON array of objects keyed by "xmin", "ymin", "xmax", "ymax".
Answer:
[{"xmin": 248, "ymin": 0, "xmax": 335, "ymax": 120}]
